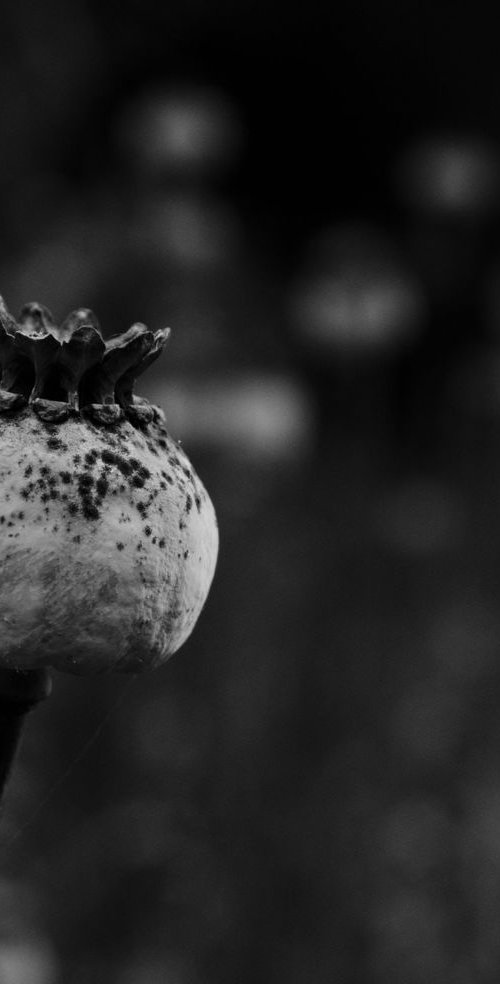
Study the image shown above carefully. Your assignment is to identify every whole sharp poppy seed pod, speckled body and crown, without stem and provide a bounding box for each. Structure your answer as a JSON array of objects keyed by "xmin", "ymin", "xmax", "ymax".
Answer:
[{"xmin": 0, "ymin": 298, "xmax": 218, "ymax": 673}]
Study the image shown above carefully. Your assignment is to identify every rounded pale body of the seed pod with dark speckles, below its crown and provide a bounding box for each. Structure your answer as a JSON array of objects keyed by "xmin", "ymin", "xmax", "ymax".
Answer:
[{"xmin": 0, "ymin": 408, "xmax": 218, "ymax": 673}]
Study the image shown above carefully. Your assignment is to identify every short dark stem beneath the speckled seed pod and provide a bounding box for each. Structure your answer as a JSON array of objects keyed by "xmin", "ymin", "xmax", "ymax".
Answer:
[{"xmin": 0, "ymin": 669, "xmax": 52, "ymax": 801}]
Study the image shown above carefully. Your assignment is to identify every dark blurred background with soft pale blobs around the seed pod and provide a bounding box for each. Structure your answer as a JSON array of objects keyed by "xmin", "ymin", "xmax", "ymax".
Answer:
[{"xmin": 4, "ymin": 0, "xmax": 500, "ymax": 984}]
